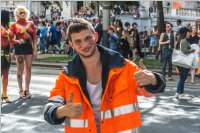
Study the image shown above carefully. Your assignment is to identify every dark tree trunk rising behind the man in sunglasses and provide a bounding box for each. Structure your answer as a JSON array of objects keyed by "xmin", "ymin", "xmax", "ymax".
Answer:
[{"xmin": 157, "ymin": 1, "xmax": 165, "ymax": 33}]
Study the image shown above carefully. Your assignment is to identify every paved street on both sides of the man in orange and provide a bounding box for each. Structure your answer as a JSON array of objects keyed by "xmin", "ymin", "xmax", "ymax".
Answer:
[{"xmin": 1, "ymin": 66, "xmax": 200, "ymax": 133}]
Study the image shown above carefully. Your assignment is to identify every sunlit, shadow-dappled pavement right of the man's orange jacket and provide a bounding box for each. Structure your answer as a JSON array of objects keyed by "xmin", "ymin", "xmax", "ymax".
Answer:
[{"xmin": 139, "ymin": 82, "xmax": 200, "ymax": 133}]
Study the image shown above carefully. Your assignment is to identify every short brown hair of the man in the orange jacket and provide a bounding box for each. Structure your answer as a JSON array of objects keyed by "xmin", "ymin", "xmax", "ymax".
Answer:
[{"xmin": 67, "ymin": 18, "xmax": 95, "ymax": 41}]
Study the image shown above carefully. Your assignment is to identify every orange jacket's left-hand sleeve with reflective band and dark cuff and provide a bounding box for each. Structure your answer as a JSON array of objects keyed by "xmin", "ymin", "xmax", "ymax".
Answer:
[{"xmin": 44, "ymin": 73, "xmax": 65, "ymax": 124}]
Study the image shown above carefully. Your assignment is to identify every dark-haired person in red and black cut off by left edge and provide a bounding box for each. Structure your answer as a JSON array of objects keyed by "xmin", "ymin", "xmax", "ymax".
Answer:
[{"xmin": 0, "ymin": 10, "xmax": 11, "ymax": 103}]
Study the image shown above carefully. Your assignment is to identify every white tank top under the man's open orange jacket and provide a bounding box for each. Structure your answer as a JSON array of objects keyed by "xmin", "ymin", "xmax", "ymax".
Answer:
[{"xmin": 87, "ymin": 81, "xmax": 102, "ymax": 133}]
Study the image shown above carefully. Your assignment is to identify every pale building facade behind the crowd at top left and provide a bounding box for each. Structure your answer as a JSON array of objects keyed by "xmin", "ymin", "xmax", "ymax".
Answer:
[{"xmin": 1, "ymin": 0, "xmax": 83, "ymax": 21}]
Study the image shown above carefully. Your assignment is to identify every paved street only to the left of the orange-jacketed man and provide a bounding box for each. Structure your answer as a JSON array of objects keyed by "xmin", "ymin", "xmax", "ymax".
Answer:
[{"xmin": 1, "ymin": 67, "xmax": 63, "ymax": 133}]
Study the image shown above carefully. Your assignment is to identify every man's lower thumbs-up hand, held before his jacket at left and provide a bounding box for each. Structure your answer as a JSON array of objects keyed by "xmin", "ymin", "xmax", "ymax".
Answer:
[{"xmin": 56, "ymin": 92, "xmax": 83, "ymax": 119}]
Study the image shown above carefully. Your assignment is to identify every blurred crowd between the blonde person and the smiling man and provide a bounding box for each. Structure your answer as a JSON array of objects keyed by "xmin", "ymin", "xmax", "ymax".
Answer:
[{"xmin": 31, "ymin": 7, "xmax": 95, "ymax": 55}]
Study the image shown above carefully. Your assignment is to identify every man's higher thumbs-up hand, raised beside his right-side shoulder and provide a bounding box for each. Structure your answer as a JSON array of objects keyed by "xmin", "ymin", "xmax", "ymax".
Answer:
[{"xmin": 134, "ymin": 59, "xmax": 157, "ymax": 87}]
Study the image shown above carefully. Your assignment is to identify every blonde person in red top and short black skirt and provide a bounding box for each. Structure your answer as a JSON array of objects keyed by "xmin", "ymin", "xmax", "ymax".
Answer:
[{"xmin": 10, "ymin": 6, "xmax": 37, "ymax": 98}]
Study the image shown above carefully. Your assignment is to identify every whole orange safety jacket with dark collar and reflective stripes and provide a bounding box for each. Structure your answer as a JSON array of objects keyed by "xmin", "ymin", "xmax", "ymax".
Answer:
[{"xmin": 45, "ymin": 46, "xmax": 165, "ymax": 133}]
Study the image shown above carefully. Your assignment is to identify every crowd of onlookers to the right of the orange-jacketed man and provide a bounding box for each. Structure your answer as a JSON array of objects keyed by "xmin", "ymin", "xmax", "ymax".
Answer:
[{"xmin": 98, "ymin": 20, "xmax": 200, "ymax": 98}]
